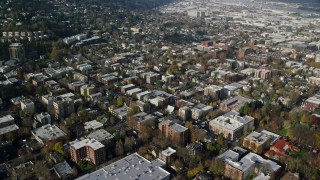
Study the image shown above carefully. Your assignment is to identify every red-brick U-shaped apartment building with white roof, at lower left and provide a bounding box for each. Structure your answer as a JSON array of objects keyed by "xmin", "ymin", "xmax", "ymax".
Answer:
[{"xmin": 70, "ymin": 139, "xmax": 106, "ymax": 165}]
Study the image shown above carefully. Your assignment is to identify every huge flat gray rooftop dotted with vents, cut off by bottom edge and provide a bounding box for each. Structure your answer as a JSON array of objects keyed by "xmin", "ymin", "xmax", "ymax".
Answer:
[{"xmin": 78, "ymin": 153, "xmax": 170, "ymax": 180}]
